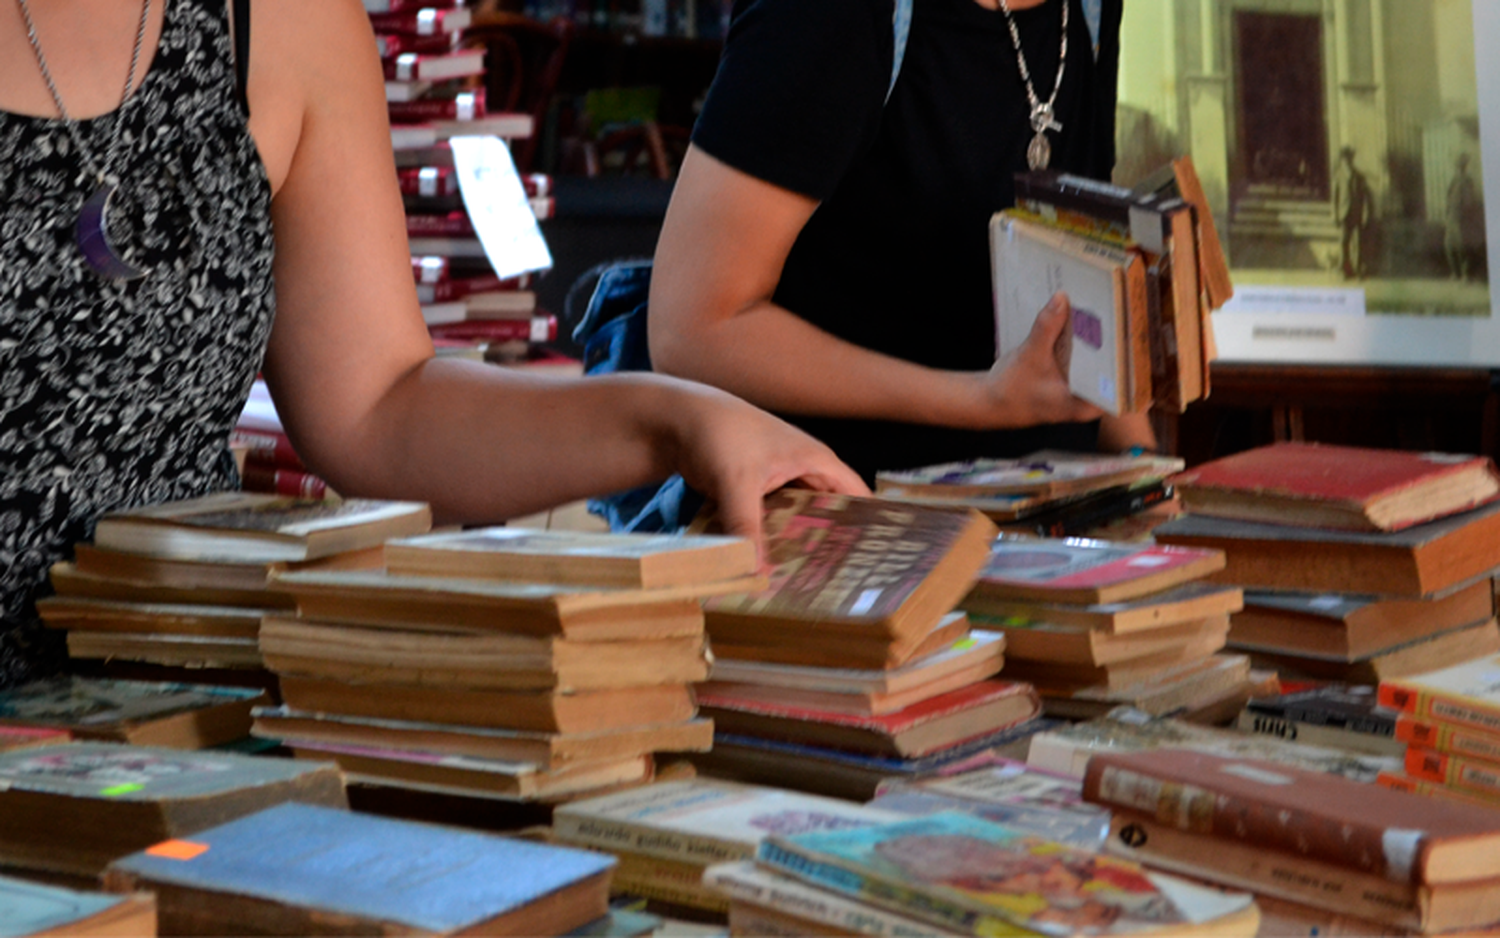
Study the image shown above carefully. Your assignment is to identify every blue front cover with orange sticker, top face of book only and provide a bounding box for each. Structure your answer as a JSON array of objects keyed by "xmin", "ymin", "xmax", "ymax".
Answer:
[{"xmin": 108, "ymin": 804, "xmax": 615, "ymax": 933}]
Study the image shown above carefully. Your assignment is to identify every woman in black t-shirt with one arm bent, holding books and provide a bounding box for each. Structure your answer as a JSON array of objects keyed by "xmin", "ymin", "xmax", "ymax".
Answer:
[{"xmin": 651, "ymin": 0, "xmax": 1154, "ymax": 479}]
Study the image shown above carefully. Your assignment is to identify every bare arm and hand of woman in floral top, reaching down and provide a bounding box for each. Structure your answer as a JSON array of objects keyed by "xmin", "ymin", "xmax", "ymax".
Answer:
[{"xmin": 249, "ymin": 0, "xmax": 864, "ymax": 534}]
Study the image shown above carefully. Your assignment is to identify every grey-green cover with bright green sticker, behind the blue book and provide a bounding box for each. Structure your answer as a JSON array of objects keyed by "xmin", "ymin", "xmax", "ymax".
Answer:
[{"xmin": 0, "ymin": 743, "xmax": 330, "ymax": 801}]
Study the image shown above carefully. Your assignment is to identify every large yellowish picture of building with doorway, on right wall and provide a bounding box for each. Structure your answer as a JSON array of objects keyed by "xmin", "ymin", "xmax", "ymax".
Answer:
[{"xmin": 1116, "ymin": 0, "xmax": 1500, "ymax": 368}]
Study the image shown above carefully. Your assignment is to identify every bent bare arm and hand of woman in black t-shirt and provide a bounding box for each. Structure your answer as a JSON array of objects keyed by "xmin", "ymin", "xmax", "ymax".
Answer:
[{"xmin": 650, "ymin": 147, "xmax": 1100, "ymax": 429}]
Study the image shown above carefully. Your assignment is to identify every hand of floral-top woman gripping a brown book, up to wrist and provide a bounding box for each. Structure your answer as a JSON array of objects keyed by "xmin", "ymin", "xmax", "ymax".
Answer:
[{"xmin": 668, "ymin": 383, "xmax": 870, "ymax": 540}]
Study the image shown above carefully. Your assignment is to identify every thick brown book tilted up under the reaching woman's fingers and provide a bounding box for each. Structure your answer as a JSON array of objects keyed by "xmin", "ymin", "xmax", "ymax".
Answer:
[{"xmin": 705, "ymin": 489, "xmax": 996, "ymax": 665}]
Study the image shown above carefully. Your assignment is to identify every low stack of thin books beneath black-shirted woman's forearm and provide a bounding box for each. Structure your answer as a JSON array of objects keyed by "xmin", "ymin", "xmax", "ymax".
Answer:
[{"xmin": 875, "ymin": 450, "xmax": 1184, "ymax": 537}]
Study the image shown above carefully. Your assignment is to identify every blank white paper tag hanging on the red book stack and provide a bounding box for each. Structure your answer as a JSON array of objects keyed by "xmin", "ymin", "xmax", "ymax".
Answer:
[{"xmin": 449, "ymin": 137, "xmax": 552, "ymax": 279}]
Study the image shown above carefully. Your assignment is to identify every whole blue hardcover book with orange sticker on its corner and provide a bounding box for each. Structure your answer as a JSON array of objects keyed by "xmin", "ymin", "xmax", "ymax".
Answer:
[{"xmin": 105, "ymin": 804, "xmax": 615, "ymax": 935}]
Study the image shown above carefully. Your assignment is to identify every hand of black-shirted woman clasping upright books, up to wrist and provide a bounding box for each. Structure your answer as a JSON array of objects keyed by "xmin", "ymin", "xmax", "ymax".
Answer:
[{"xmin": 980, "ymin": 293, "xmax": 1104, "ymax": 429}]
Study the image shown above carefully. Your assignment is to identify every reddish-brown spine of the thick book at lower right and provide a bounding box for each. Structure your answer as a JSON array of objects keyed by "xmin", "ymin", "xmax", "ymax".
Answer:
[{"xmin": 1083, "ymin": 755, "xmax": 1425, "ymax": 882}]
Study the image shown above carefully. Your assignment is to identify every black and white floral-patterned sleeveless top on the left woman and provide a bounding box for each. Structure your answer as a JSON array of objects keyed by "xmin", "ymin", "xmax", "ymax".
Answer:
[{"xmin": 0, "ymin": 0, "xmax": 275, "ymax": 686}]
